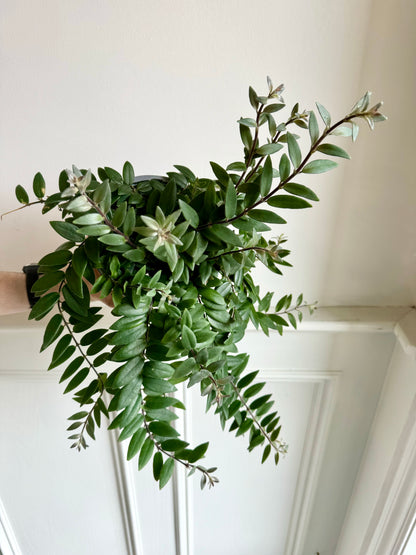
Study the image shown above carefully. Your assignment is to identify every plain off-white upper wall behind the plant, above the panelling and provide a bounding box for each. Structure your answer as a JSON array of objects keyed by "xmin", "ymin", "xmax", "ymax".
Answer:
[{"xmin": 0, "ymin": 0, "xmax": 416, "ymax": 305}]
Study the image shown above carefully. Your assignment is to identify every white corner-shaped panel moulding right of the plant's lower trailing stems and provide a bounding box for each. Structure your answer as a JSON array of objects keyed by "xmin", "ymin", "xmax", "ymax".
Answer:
[{"xmin": 259, "ymin": 370, "xmax": 341, "ymax": 555}]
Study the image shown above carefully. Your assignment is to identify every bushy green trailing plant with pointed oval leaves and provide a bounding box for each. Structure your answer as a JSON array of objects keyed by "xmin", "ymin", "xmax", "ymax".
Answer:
[{"xmin": 6, "ymin": 79, "xmax": 386, "ymax": 488}]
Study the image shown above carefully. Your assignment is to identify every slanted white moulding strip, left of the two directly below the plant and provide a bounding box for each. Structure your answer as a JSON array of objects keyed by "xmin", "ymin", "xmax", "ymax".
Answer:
[{"xmin": 108, "ymin": 394, "xmax": 144, "ymax": 555}]
